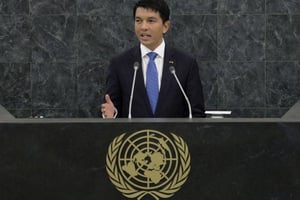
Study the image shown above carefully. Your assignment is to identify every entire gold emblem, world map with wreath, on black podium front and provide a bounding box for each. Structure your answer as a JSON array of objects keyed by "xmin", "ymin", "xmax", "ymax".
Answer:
[{"xmin": 106, "ymin": 129, "xmax": 191, "ymax": 200}]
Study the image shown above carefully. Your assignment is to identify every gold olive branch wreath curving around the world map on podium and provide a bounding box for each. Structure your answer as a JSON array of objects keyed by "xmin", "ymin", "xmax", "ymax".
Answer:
[{"xmin": 106, "ymin": 133, "xmax": 191, "ymax": 200}]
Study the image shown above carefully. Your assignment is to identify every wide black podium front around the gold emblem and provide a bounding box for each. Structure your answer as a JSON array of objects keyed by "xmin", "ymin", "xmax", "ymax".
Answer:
[{"xmin": 0, "ymin": 118, "xmax": 300, "ymax": 200}]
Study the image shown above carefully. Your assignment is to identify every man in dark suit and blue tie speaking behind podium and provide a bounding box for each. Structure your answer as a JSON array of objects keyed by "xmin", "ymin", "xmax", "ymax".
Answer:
[{"xmin": 101, "ymin": 0, "xmax": 205, "ymax": 118}]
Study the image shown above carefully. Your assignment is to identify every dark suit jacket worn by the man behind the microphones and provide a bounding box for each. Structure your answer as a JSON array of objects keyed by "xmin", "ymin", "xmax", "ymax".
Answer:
[{"xmin": 106, "ymin": 45, "xmax": 205, "ymax": 118}]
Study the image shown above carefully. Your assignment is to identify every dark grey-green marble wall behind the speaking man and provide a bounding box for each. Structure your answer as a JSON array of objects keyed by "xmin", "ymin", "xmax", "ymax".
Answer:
[{"xmin": 0, "ymin": 0, "xmax": 300, "ymax": 117}]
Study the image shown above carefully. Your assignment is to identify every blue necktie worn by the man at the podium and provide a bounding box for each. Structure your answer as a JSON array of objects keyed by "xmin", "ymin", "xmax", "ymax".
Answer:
[{"xmin": 146, "ymin": 52, "xmax": 159, "ymax": 113}]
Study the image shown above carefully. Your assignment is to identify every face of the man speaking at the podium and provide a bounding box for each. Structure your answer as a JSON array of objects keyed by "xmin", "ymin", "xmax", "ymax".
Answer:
[{"xmin": 134, "ymin": 7, "xmax": 170, "ymax": 50}]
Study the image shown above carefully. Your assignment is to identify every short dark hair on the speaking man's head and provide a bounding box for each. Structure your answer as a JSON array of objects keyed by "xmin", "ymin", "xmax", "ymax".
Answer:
[{"xmin": 133, "ymin": 0, "xmax": 170, "ymax": 23}]
